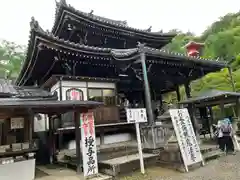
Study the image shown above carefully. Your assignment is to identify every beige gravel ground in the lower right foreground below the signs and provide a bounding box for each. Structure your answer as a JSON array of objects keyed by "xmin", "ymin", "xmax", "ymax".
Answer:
[{"xmin": 121, "ymin": 153, "xmax": 240, "ymax": 180}]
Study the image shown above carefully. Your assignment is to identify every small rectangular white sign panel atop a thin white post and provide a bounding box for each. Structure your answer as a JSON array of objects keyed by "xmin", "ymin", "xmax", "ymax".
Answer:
[{"xmin": 126, "ymin": 108, "xmax": 147, "ymax": 123}]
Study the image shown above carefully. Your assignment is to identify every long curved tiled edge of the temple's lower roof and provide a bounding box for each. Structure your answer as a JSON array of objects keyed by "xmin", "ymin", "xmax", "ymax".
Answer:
[{"xmin": 17, "ymin": 17, "xmax": 225, "ymax": 86}]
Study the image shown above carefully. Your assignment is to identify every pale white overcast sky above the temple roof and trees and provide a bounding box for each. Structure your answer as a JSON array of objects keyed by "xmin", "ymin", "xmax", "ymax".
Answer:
[{"xmin": 0, "ymin": 0, "xmax": 240, "ymax": 45}]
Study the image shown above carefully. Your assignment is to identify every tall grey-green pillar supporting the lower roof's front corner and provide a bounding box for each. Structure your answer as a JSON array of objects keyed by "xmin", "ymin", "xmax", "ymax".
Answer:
[{"xmin": 140, "ymin": 47, "xmax": 154, "ymax": 124}]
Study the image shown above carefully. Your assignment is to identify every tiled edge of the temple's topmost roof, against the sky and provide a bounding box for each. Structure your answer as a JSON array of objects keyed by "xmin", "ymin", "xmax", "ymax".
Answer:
[{"xmin": 52, "ymin": 0, "xmax": 176, "ymax": 37}]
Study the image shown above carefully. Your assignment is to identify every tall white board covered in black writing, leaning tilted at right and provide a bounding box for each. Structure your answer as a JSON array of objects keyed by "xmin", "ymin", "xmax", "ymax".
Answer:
[{"xmin": 169, "ymin": 108, "xmax": 203, "ymax": 167}]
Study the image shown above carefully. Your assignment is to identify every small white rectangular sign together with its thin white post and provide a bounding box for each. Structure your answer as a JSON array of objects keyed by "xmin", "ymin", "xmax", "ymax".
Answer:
[{"xmin": 126, "ymin": 108, "xmax": 147, "ymax": 174}]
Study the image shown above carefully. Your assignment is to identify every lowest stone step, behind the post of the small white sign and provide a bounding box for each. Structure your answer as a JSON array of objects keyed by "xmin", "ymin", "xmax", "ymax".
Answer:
[{"xmin": 98, "ymin": 153, "xmax": 158, "ymax": 177}]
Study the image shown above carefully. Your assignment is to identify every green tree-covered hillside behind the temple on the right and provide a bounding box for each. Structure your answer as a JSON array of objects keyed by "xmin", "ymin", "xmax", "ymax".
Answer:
[{"xmin": 165, "ymin": 12, "xmax": 240, "ymax": 103}]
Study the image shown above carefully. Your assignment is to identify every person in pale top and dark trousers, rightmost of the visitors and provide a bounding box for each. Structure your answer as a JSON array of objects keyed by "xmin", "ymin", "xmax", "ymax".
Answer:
[{"xmin": 220, "ymin": 118, "xmax": 234, "ymax": 153}]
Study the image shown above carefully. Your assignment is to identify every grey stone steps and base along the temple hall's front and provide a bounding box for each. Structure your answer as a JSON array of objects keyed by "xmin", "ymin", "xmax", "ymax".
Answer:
[{"xmin": 57, "ymin": 142, "xmax": 223, "ymax": 177}]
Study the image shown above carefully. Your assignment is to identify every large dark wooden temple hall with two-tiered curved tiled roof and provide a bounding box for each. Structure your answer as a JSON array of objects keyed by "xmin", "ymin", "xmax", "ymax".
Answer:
[{"xmin": 7, "ymin": 0, "xmax": 225, "ymax": 176}]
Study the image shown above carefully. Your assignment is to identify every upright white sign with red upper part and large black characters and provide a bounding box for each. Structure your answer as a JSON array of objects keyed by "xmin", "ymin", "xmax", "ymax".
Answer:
[{"xmin": 80, "ymin": 113, "xmax": 98, "ymax": 177}]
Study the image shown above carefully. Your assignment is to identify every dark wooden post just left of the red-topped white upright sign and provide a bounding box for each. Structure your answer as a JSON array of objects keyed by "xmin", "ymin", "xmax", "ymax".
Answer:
[{"xmin": 74, "ymin": 111, "xmax": 81, "ymax": 174}]
